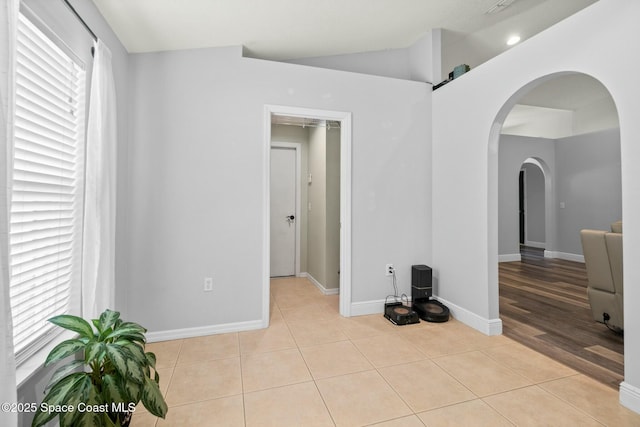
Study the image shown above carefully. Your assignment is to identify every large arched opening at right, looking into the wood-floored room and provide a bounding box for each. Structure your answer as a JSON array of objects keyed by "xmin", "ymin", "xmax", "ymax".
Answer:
[{"xmin": 489, "ymin": 73, "xmax": 624, "ymax": 388}]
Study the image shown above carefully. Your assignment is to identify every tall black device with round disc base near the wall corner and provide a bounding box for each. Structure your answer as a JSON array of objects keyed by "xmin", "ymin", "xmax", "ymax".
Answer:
[{"xmin": 411, "ymin": 264, "xmax": 449, "ymax": 323}]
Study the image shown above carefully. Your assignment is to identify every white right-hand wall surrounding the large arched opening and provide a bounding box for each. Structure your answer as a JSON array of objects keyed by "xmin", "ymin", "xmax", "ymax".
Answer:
[{"xmin": 432, "ymin": 0, "xmax": 640, "ymax": 412}]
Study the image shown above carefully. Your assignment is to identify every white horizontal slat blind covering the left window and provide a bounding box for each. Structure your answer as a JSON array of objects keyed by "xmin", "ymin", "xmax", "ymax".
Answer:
[{"xmin": 10, "ymin": 15, "xmax": 85, "ymax": 362}]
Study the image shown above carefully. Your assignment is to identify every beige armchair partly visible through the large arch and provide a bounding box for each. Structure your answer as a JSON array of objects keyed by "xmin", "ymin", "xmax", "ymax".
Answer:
[{"xmin": 580, "ymin": 221, "xmax": 624, "ymax": 331}]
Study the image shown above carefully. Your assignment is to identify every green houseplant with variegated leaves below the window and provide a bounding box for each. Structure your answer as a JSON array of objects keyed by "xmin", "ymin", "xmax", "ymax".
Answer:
[{"xmin": 32, "ymin": 310, "xmax": 167, "ymax": 427}]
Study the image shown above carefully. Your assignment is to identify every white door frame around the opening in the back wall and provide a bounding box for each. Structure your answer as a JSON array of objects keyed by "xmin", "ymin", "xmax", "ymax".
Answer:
[{"xmin": 262, "ymin": 105, "xmax": 352, "ymax": 328}]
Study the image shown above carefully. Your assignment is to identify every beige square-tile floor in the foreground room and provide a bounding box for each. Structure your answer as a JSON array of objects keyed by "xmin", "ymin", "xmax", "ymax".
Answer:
[{"xmin": 132, "ymin": 278, "xmax": 640, "ymax": 427}]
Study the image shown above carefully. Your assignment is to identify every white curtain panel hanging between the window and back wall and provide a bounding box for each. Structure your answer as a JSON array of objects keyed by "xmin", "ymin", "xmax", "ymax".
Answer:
[{"xmin": 82, "ymin": 40, "xmax": 117, "ymax": 319}]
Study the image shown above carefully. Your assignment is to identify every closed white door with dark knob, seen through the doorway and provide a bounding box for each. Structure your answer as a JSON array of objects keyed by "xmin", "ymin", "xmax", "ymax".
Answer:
[{"xmin": 271, "ymin": 147, "xmax": 298, "ymax": 277}]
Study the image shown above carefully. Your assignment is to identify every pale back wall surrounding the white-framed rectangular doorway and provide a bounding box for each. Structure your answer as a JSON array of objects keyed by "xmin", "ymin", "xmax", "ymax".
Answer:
[{"xmin": 122, "ymin": 48, "xmax": 431, "ymax": 337}]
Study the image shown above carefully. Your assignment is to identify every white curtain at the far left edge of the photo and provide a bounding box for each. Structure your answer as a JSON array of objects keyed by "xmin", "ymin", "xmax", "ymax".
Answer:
[{"xmin": 0, "ymin": 0, "xmax": 19, "ymax": 426}]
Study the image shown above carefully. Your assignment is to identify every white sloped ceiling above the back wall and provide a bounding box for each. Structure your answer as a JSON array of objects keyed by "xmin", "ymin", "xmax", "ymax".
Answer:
[{"xmin": 93, "ymin": 0, "xmax": 596, "ymax": 60}]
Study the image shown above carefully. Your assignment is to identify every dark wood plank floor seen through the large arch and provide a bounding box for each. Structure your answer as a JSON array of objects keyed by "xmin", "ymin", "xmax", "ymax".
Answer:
[{"xmin": 499, "ymin": 248, "xmax": 624, "ymax": 389}]
